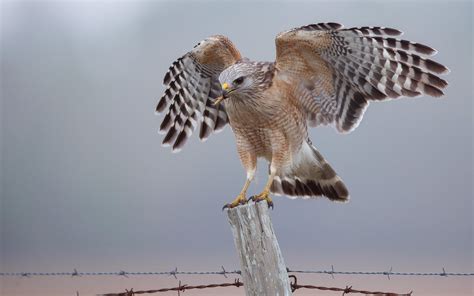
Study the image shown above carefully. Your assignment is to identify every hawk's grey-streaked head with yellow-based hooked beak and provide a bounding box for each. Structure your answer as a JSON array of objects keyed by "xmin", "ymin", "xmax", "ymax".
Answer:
[{"xmin": 215, "ymin": 62, "xmax": 272, "ymax": 104}]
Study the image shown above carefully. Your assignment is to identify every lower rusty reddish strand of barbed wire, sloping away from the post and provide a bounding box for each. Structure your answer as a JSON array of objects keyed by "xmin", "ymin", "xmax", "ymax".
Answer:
[{"xmin": 100, "ymin": 275, "xmax": 412, "ymax": 296}]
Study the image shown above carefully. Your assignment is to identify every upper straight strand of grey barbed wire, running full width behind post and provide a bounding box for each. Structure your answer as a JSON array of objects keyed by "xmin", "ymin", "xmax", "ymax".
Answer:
[{"xmin": 0, "ymin": 265, "xmax": 474, "ymax": 279}]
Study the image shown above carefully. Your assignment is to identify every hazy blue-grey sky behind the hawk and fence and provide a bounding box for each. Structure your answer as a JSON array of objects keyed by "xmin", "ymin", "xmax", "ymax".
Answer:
[{"xmin": 0, "ymin": 1, "xmax": 473, "ymax": 295}]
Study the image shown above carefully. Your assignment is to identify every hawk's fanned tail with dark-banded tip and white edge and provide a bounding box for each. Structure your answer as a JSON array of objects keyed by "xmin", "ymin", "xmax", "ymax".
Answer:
[{"xmin": 270, "ymin": 142, "xmax": 349, "ymax": 202}]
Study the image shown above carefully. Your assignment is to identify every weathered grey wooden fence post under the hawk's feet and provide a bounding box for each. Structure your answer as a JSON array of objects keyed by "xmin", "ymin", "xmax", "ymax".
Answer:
[{"xmin": 228, "ymin": 202, "xmax": 291, "ymax": 296}]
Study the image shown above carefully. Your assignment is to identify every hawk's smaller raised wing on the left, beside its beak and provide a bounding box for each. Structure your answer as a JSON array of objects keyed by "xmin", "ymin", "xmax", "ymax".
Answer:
[{"xmin": 156, "ymin": 35, "xmax": 241, "ymax": 152}]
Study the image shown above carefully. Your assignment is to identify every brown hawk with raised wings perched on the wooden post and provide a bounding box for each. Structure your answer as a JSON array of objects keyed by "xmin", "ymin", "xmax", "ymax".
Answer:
[{"xmin": 156, "ymin": 23, "xmax": 449, "ymax": 208}]
